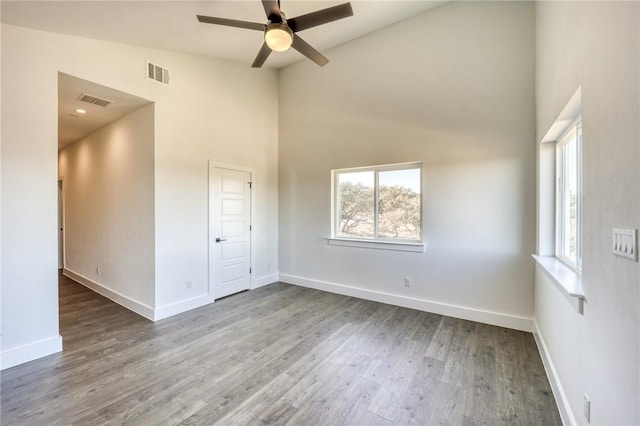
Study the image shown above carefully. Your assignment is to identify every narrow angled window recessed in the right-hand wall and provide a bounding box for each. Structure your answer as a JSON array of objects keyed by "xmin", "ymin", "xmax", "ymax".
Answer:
[{"xmin": 556, "ymin": 119, "xmax": 582, "ymax": 269}]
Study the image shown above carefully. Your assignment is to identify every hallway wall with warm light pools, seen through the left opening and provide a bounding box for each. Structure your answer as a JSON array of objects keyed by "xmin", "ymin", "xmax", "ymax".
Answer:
[{"xmin": 58, "ymin": 104, "xmax": 155, "ymax": 316}]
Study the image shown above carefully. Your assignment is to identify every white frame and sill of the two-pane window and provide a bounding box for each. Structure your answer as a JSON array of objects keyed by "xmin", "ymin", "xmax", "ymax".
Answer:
[{"xmin": 329, "ymin": 162, "xmax": 425, "ymax": 252}]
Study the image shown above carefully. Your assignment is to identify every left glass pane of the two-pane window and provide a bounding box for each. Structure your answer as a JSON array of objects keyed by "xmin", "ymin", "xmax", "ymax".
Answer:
[{"xmin": 336, "ymin": 171, "xmax": 375, "ymax": 238}]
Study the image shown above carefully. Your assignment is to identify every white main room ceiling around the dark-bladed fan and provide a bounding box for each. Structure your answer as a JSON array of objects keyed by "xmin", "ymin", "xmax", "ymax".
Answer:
[{"xmin": 0, "ymin": 0, "xmax": 446, "ymax": 68}]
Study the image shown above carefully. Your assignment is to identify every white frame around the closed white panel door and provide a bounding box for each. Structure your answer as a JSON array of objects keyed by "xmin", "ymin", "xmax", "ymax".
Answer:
[{"xmin": 207, "ymin": 160, "xmax": 256, "ymax": 303}]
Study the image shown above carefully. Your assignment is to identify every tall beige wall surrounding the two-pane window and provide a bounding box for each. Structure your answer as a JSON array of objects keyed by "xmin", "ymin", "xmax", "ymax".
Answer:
[{"xmin": 279, "ymin": 2, "xmax": 535, "ymax": 329}]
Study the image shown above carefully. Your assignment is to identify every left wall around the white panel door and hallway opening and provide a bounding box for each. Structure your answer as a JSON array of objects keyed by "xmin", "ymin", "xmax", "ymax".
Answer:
[{"xmin": 1, "ymin": 24, "xmax": 278, "ymax": 368}]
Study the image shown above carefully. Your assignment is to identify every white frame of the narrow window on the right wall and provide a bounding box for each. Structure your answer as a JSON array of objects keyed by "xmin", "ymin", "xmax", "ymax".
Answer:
[{"xmin": 555, "ymin": 117, "xmax": 582, "ymax": 272}]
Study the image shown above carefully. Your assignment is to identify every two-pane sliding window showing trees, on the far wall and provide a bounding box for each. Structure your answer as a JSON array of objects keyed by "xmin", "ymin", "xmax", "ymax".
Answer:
[{"xmin": 333, "ymin": 163, "xmax": 422, "ymax": 242}]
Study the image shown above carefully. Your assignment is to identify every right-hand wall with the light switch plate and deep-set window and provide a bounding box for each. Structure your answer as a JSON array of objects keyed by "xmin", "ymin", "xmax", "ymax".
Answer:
[{"xmin": 535, "ymin": 1, "xmax": 640, "ymax": 425}]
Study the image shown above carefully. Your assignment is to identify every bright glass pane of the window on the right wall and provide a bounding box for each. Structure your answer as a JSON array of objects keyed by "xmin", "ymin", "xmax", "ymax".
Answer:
[{"xmin": 562, "ymin": 136, "xmax": 578, "ymax": 262}]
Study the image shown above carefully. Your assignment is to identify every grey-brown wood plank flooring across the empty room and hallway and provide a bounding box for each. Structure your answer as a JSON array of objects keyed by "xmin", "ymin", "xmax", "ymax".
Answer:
[{"xmin": 0, "ymin": 277, "xmax": 561, "ymax": 426}]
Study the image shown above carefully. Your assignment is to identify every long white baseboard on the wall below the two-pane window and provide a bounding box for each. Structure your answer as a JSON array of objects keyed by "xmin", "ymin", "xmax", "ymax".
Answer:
[{"xmin": 279, "ymin": 274, "xmax": 532, "ymax": 332}]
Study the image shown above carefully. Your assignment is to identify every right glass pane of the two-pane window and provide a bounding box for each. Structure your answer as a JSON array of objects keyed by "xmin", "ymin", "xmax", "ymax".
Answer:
[{"xmin": 378, "ymin": 169, "xmax": 420, "ymax": 241}]
